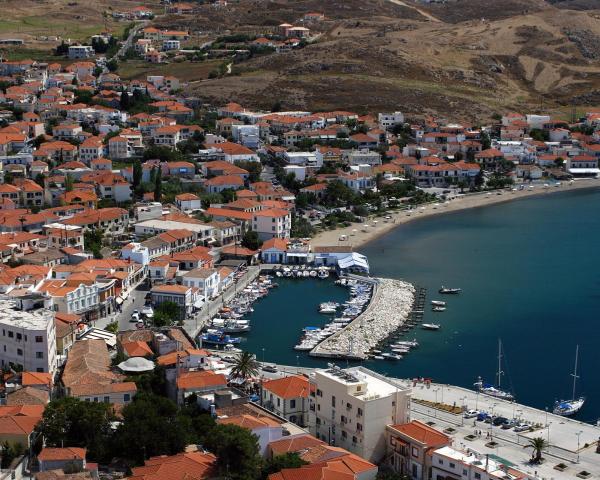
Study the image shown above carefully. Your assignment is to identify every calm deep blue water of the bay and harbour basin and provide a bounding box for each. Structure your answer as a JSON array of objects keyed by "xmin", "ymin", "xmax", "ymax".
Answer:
[{"xmin": 241, "ymin": 191, "xmax": 600, "ymax": 421}]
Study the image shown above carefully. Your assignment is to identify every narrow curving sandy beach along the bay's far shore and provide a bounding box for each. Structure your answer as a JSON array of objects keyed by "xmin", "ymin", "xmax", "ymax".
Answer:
[{"xmin": 310, "ymin": 179, "xmax": 600, "ymax": 249}]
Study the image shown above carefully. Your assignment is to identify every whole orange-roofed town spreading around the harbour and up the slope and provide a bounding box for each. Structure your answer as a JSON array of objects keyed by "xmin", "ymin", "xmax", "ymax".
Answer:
[{"xmin": 0, "ymin": 0, "xmax": 600, "ymax": 480}]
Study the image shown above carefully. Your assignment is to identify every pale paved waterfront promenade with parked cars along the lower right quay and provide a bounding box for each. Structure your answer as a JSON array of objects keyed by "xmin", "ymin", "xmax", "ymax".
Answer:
[{"xmin": 209, "ymin": 352, "xmax": 600, "ymax": 480}]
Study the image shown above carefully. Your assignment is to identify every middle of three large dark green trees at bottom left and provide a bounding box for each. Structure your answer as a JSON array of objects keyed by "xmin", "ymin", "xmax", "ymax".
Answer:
[{"xmin": 114, "ymin": 392, "xmax": 194, "ymax": 464}]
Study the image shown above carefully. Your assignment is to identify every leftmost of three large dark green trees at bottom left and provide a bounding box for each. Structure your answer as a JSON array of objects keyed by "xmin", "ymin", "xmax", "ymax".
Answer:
[{"xmin": 36, "ymin": 397, "xmax": 114, "ymax": 461}]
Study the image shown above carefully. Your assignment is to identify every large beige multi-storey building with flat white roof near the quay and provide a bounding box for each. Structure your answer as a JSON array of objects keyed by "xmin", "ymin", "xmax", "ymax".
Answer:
[{"xmin": 309, "ymin": 367, "xmax": 411, "ymax": 462}]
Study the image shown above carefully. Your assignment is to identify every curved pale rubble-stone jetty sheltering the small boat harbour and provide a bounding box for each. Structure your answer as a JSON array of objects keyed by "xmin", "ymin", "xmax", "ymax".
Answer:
[{"xmin": 310, "ymin": 278, "xmax": 415, "ymax": 360}]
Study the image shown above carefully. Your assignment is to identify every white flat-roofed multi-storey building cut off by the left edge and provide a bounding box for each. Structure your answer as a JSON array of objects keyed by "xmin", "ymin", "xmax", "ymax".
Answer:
[{"xmin": 0, "ymin": 301, "xmax": 57, "ymax": 374}]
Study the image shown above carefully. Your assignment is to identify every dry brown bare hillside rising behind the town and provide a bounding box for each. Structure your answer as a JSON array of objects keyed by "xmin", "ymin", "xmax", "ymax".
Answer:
[{"xmin": 180, "ymin": 0, "xmax": 600, "ymax": 121}]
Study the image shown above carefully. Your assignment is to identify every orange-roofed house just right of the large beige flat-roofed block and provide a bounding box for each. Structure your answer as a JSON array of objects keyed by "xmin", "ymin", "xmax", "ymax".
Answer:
[{"xmin": 386, "ymin": 420, "xmax": 452, "ymax": 480}]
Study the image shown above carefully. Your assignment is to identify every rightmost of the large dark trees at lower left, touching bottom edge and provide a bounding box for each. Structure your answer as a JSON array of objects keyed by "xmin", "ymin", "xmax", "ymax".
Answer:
[{"xmin": 205, "ymin": 424, "xmax": 262, "ymax": 480}]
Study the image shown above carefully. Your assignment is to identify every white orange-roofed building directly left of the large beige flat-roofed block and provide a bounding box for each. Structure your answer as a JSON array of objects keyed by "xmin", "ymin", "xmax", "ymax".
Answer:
[{"xmin": 262, "ymin": 375, "xmax": 309, "ymax": 427}]
